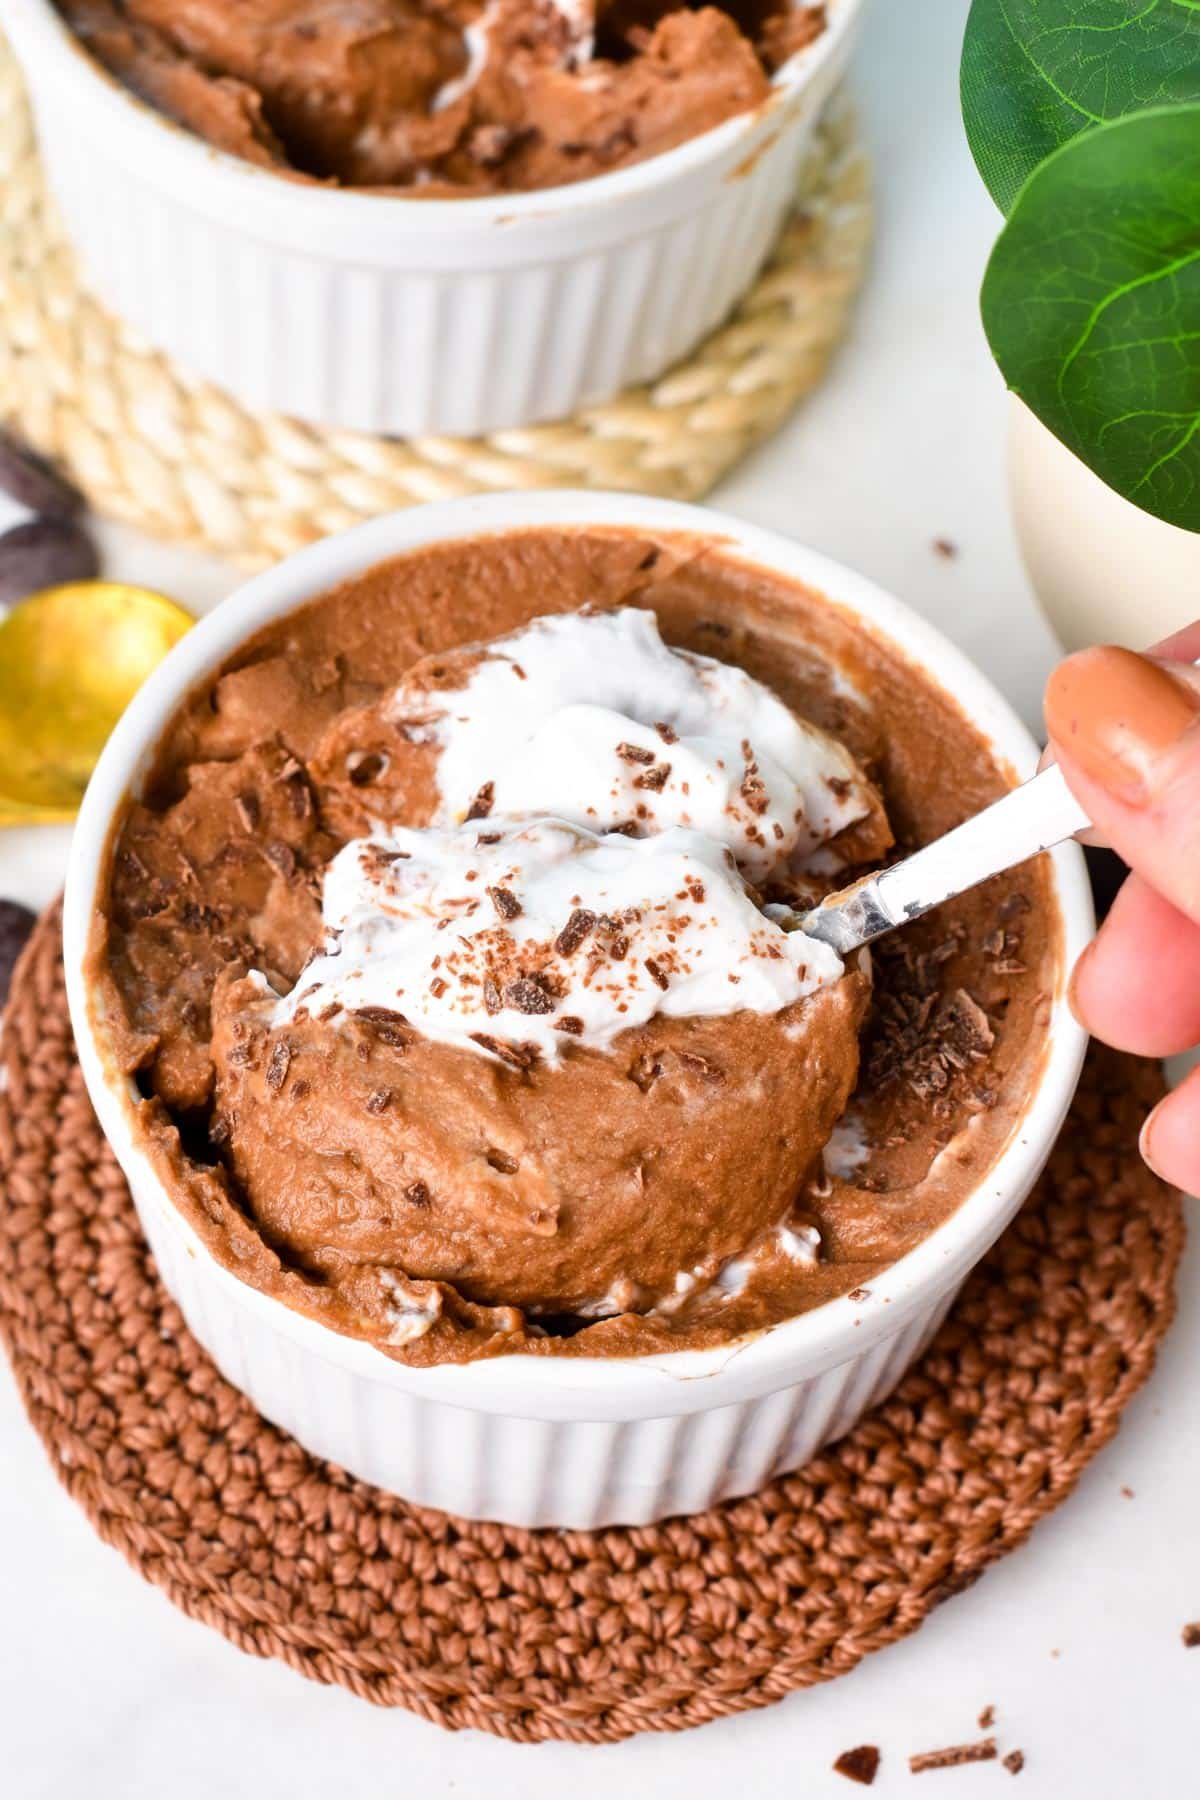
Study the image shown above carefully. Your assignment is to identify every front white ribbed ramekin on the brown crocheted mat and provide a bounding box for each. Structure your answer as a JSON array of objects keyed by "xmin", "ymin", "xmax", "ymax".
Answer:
[{"xmin": 63, "ymin": 493, "xmax": 1092, "ymax": 1526}]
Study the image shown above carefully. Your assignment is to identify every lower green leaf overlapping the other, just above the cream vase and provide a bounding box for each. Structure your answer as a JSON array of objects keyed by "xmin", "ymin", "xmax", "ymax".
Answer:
[{"xmin": 982, "ymin": 106, "xmax": 1200, "ymax": 531}]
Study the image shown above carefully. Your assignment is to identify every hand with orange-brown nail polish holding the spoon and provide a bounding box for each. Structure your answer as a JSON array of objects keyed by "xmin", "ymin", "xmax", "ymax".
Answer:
[{"xmin": 1045, "ymin": 623, "xmax": 1200, "ymax": 1193}]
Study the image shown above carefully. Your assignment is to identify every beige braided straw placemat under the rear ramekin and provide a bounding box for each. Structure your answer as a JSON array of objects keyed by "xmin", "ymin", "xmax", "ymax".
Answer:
[{"xmin": 0, "ymin": 34, "xmax": 871, "ymax": 563}]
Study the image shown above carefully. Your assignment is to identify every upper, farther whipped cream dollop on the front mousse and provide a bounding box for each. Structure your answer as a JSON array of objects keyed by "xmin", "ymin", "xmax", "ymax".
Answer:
[{"xmin": 389, "ymin": 607, "xmax": 871, "ymax": 882}]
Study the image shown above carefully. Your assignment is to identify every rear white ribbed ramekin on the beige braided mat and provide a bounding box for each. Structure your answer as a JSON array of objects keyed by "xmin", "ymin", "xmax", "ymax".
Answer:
[{"xmin": 4, "ymin": 0, "xmax": 862, "ymax": 436}]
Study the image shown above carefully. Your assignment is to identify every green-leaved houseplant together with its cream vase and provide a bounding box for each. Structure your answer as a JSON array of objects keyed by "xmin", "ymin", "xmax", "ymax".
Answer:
[{"xmin": 961, "ymin": 0, "xmax": 1200, "ymax": 644}]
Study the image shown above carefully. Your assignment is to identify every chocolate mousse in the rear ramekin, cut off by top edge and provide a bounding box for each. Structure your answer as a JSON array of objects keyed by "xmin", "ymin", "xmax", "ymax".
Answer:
[{"xmin": 58, "ymin": 0, "xmax": 824, "ymax": 196}]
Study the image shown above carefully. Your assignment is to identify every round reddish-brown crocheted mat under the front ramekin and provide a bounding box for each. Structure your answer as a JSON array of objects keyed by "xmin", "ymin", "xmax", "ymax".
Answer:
[{"xmin": 0, "ymin": 909, "xmax": 1184, "ymax": 1742}]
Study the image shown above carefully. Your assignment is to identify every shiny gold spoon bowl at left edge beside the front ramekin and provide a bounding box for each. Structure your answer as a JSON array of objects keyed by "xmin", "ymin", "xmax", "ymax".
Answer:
[{"xmin": 0, "ymin": 581, "xmax": 193, "ymax": 828}]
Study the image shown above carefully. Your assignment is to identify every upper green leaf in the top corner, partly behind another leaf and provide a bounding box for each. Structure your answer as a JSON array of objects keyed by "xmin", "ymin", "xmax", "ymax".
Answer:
[{"xmin": 961, "ymin": 0, "xmax": 1200, "ymax": 212}]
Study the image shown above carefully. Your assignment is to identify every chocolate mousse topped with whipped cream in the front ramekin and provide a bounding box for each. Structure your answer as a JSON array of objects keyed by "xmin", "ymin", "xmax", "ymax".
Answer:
[{"xmin": 92, "ymin": 531, "xmax": 1060, "ymax": 1363}]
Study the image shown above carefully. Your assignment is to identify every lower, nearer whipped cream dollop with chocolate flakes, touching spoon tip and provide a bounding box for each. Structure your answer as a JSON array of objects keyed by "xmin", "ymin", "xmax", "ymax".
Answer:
[{"xmin": 273, "ymin": 820, "xmax": 842, "ymax": 1062}]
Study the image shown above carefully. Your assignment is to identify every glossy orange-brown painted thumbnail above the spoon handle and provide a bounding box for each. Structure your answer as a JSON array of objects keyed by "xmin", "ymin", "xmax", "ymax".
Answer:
[{"xmin": 1045, "ymin": 644, "xmax": 1200, "ymax": 803}]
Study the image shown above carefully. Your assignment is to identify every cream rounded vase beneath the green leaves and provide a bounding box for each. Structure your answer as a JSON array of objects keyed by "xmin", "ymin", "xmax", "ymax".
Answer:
[{"xmin": 1009, "ymin": 400, "xmax": 1200, "ymax": 650}]
